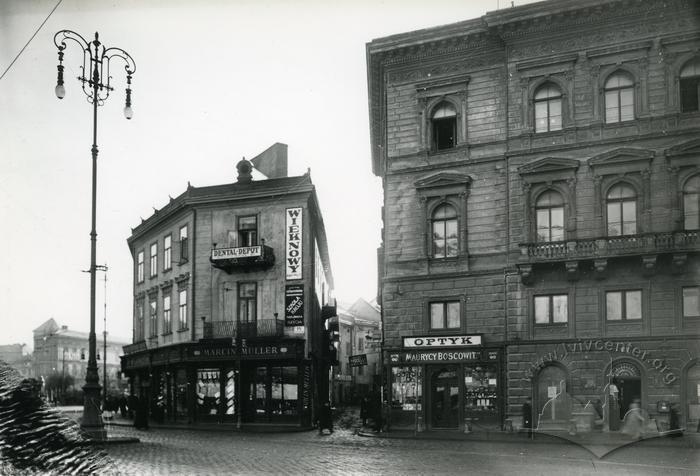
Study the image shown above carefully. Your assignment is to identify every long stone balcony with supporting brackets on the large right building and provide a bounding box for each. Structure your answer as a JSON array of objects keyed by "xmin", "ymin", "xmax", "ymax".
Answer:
[{"xmin": 518, "ymin": 230, "xmax": 700, "ymax": 284}]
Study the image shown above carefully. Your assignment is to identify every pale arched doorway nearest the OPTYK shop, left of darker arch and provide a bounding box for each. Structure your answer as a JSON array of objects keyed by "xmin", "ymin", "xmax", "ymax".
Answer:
[{"xmin": 534, "ymin": 365, "xmax": 571, "ymax": 429}]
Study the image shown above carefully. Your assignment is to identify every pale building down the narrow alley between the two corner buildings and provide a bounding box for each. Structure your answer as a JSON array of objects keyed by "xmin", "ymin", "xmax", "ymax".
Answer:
[{"xmin": 333, "ymin": 299, "xmax": 382, "ymax": 404}]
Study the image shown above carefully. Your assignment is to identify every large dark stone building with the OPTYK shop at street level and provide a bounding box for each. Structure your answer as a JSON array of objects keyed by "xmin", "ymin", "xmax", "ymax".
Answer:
[{"xmin": 367, "ymin": 0, "xmax": 700, "ymax": 431}]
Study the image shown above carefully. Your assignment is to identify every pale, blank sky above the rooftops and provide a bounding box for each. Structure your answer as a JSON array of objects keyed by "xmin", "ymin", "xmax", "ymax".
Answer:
[{"xmin": 0, "ymin": 0, "xmax": 540, "ymax": 350}]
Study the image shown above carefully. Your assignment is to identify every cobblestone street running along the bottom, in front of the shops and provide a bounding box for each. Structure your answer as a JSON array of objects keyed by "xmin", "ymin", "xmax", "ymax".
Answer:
[{"xmin": 101, "ymin": 426, "xmax": 700, "ymax": 476}]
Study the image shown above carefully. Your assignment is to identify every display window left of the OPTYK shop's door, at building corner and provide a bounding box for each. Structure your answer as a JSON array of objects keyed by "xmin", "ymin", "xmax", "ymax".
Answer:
[{"xmin": 391, "ymin": 367, "xmax": 423, "ymax": 429}]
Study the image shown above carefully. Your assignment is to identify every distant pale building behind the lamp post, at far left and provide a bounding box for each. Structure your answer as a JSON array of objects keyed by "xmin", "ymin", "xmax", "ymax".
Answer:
[{"xmin": 32, "ymin": 318, "xmax": 126, "ymax": 394}]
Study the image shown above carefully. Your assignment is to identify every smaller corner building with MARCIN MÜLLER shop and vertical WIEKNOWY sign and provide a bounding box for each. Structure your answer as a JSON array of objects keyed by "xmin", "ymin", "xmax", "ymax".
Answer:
[{"xmin": 123, "ymin": 144, "xmax": 333, "ymax": 427}]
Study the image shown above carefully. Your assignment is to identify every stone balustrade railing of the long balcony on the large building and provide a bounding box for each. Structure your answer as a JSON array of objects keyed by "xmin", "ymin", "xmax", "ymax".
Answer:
[{"xmin": 520, "ymin": 231, "xmax": 700, "ymax": 262}]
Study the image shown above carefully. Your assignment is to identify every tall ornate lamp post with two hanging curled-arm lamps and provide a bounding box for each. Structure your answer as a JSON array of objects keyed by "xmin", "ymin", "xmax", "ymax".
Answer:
[{"xmin": 53, "ymin": 30, "xmax": 136, "ymax": 440}]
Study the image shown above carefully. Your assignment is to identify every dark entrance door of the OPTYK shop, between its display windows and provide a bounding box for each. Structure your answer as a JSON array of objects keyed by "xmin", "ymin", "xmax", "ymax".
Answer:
[{"xmin": 430, "ymin": 365, "xmax": 459, "ymax": 429}]
